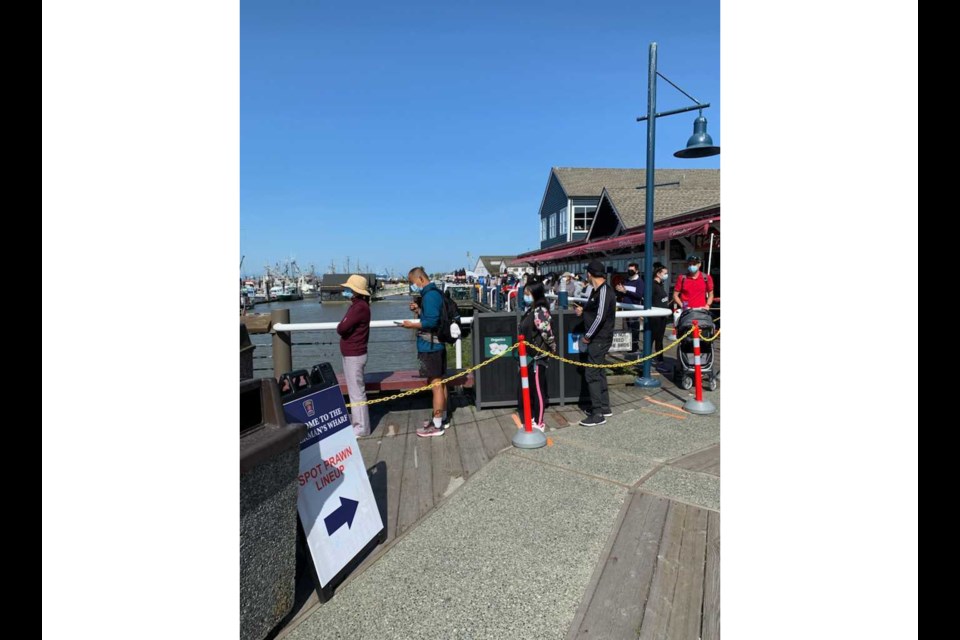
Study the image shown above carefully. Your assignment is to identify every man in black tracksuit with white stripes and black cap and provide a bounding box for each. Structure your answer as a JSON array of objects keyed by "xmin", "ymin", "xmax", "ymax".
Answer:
[{"xmin": 576, "ymin": 260, "xmax": 617, "ymax": 427}]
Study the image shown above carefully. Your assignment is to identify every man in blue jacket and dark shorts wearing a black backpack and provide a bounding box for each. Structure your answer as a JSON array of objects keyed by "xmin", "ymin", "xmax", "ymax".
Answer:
[{"xmin": 402, "ymin": 267, "xmax": 460, "ymax": 438}]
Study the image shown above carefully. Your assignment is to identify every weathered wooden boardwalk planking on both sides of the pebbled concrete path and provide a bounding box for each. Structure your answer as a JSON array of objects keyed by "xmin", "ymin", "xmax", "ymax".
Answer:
[{"xmin": 275, "ymin": 352, "xmax": 719, "ymax": 638}]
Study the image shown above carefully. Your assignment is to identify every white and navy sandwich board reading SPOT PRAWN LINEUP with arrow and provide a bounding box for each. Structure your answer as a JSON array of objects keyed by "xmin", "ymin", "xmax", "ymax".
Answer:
[{"xmin": 283, "ymin": 386, "xmax": 383, "ymax": 586}]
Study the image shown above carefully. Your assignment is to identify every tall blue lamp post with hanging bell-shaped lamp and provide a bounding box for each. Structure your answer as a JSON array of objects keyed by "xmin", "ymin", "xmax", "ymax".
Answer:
[{"xmin": 634, "ymin": 42, "xmax": 720, "ymax": 387}]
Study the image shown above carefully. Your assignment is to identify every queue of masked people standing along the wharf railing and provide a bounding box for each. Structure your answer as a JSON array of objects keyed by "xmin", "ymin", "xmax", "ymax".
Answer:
[{"xmin": 337, "ymin": 255, "xmax": 714, "ymax": 438}]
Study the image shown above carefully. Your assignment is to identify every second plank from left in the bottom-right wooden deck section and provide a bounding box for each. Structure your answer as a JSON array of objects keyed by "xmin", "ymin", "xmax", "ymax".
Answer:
[{"xmin": 639, "ymin": 501, "xmax": 695, "ymax": 640}]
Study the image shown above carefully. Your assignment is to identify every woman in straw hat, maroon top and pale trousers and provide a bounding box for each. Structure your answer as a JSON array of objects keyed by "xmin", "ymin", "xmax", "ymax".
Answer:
[{"xmin": 337, "ymin": 274, "xmax": 370, "ymax": 436}]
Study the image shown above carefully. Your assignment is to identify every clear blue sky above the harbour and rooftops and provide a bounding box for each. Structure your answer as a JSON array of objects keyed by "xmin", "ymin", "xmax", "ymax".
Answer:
[{"xmin": 240, "ymin": 0, "xmax": 723, "ymax": 273}]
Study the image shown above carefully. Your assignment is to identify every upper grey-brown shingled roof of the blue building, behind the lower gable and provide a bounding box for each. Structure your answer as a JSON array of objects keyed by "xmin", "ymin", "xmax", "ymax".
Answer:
[{"xmin": 553, "ymin": 167, "xmax": 720, "ymax": 202}]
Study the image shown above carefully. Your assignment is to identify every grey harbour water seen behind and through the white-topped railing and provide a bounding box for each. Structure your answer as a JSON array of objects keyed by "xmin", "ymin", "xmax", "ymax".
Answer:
[{"xmin": 250, "ymin": 296, "xmax": 418, "ymax": 377}]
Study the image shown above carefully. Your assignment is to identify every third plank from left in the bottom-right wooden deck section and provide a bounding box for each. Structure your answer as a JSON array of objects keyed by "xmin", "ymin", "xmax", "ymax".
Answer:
[{"xmin": 666, "ymin": 507, "xmax": 708, "ymax": 640}]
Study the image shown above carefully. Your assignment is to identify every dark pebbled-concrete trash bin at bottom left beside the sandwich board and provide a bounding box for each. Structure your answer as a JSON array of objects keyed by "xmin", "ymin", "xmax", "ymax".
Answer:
[{"xmin": 240, "ymin": 378, "xmax": 307, "ymax": 640}]
